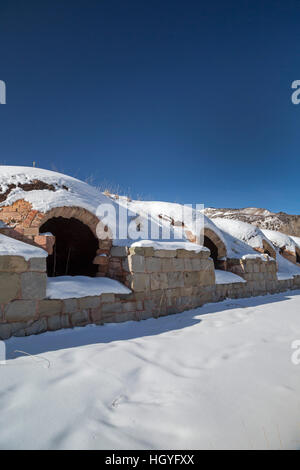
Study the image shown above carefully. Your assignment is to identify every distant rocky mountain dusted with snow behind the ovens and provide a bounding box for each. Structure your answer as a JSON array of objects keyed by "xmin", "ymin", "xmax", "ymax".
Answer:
[{"xmin": 204, "ymin": 207, "xmax": 300, "ymax": 237}]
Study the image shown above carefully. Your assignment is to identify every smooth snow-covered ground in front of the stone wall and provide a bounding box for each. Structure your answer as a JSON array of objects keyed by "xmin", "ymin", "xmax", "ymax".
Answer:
[{"xmin": 0, "ymin": 291, "xmax": 300, "ymax": 449}]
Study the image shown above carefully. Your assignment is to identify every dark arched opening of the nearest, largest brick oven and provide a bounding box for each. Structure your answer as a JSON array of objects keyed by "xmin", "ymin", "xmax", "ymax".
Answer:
[{"xmin": 40, "ymin": 217, "xmax": 99, "ymax": 277}]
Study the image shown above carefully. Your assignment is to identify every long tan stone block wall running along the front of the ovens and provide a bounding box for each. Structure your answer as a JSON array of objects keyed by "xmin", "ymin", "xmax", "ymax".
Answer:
[{"xmin": 0, "ymin": 247, "xmax": 300, "ymax": 339}]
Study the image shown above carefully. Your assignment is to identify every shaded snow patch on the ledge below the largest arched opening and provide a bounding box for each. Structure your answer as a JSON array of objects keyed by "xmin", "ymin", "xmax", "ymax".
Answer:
[{"xmin": 46, "ymin": 276, "xmax": 131, "ymax": 299}]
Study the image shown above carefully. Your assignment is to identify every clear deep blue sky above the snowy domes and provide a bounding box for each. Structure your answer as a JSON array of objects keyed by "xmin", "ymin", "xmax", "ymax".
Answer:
[{"xmin": 0, "ymin": 0, "xmax": 300, "ymax": 213}]
